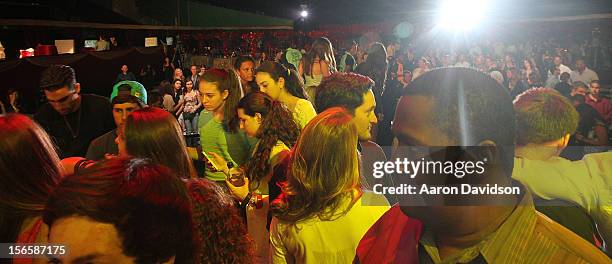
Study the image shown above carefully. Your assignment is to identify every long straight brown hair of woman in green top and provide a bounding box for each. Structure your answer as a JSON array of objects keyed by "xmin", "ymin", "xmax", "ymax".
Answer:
[{"xmin": 200, "ymin": 68, "xmax": 244, "ymax": 132}]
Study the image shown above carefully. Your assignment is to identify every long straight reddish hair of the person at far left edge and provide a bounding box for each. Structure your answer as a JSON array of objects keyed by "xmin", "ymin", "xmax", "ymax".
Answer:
[{"xmin": 0, "ymin": 114, "xmax": 62, "ymax": 243}]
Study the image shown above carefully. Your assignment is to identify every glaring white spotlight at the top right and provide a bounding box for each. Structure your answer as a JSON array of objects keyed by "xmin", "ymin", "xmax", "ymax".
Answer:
[{"xmin": 438, "ymin": 0, "xmax": 488, "ymax": 31}]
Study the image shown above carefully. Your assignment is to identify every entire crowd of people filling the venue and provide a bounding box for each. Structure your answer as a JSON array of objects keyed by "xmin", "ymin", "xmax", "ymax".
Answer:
[{"xmin": 0, "ymin": 32, "xmax": 612, "ymax": 263}]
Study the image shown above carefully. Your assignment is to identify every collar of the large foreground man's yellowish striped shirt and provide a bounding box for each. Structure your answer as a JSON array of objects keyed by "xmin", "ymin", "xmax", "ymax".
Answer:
[{"xmin": 419, "ymin": 188, "xmax": 537, "ymax": 263}]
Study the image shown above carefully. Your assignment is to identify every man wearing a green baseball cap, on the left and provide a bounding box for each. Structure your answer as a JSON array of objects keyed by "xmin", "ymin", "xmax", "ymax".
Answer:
[{"xmin": 86, "ymin": 81, "xmax": 147, "ymax": 160}]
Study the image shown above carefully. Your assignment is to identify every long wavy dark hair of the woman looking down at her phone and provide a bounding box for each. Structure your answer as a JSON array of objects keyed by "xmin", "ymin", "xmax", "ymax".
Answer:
[{"xmin": 238, "ymin": 92, "xmax": 300, "ymax": 186}]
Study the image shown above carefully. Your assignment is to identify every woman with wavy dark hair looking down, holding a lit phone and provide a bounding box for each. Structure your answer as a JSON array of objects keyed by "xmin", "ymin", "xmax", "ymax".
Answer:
[{"xmin": 213, "ymin": 92, "xmax": 300, "ymax": 260}]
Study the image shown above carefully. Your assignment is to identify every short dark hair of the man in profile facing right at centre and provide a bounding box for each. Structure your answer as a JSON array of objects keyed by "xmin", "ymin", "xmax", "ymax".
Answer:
[{"xmin": 315, "ymin": 72, "xmax": 374, "ymax": 114}]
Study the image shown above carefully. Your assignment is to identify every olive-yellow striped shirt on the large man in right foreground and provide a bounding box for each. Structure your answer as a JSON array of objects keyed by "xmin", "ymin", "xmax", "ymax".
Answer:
[{"xmin": 419, "ymin": 192, "xmax": 611, "ymax": 263}]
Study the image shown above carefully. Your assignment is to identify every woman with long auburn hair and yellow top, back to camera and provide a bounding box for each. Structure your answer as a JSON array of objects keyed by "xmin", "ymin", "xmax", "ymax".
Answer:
[{"xmin": 270, "ymin": 107, "xmax": 389, "ymax": 263}]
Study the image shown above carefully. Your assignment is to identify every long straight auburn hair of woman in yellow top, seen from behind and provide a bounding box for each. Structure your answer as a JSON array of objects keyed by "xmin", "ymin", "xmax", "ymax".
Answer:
[{"xmin": 271, "ymin": 107, "xmax": 360, "ymax": 223}]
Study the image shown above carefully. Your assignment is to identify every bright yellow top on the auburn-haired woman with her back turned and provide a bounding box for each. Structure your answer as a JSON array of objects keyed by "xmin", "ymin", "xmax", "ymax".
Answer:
[{"xmin": 270, "ymin": 192, "xmax": 389, "ymax": 263}]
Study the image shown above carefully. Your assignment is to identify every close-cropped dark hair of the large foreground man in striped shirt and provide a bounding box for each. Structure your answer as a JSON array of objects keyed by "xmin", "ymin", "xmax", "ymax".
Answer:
[{"xmin": 402, "ymin": 68, "xmax": 515, "ymax": 176}]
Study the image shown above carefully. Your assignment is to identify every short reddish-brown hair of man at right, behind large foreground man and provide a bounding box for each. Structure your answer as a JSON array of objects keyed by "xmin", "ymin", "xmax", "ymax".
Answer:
[{"xmin": 514, "ymin": 88, "xmax": 579, "ymax": 146}]
